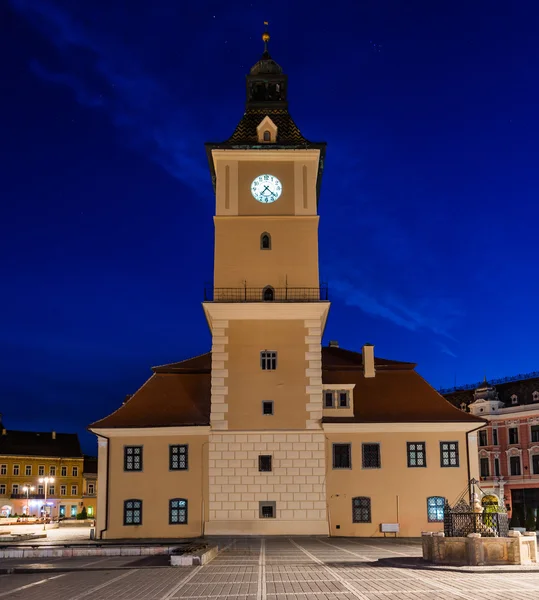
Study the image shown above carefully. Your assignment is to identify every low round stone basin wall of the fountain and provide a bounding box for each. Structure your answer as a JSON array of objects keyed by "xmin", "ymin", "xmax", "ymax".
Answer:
[{"xmin": 421, "ymin": 531, "xmax": 537, "ymax": 566}]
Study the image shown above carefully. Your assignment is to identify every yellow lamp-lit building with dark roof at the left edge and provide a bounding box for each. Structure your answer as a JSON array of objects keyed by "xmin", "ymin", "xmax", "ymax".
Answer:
[{"xmin": 0, "ymin": 419, "xmax": 96, "ymax": 519}]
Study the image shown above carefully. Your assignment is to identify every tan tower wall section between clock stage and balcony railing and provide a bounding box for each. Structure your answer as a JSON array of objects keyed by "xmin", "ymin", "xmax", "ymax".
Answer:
[{"xmin": 214, "ymin": 216, "xmax": 319, "ymax": 288}]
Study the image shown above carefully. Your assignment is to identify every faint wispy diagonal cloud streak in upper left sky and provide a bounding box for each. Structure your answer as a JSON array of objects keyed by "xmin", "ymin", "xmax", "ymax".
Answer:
[{"xmin": 10, "ymin": 0, "xmax": 207, "ymax": 189}]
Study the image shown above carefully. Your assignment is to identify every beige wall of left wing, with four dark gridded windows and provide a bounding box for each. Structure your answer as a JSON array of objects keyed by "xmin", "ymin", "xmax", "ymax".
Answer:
[{"xmin": 105, "ymin": 435, "xmax": 208, "ymax": 539}]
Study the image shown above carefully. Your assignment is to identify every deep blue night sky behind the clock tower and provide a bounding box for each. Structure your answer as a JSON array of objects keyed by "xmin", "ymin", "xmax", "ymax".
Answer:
[{"xmin": 0, "ymin": 0, "xmax": 539, "ymax": 451}]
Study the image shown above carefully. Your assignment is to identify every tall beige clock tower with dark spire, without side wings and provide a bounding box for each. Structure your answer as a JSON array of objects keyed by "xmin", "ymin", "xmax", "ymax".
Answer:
[{"xmin": 204, "ymin": 32, "xmax": 329, "ymax": 534}]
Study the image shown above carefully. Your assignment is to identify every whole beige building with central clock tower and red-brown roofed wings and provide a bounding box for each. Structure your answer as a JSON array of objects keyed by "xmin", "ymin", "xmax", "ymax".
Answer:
[{"xmin": 90, "ymin": 34, "xmax": 484, "ymax": 538}]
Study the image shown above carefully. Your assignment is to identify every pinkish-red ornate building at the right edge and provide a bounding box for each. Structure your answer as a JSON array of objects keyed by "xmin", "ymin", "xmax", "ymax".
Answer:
[{"xmin": 445, "ymin": 373, "xmax": 539, "ymax": 515}]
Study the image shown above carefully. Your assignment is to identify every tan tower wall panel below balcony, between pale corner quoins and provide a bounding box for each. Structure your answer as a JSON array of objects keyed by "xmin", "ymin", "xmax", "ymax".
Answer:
[{"xmin": 226, "ymin": 321, "xmax": 309, "ymax": 430}]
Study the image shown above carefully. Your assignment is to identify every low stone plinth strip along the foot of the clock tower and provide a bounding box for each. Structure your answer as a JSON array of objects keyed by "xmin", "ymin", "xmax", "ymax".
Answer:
[{"xmin": 204, "ymin": 519, "xmax": 329, "ymax": 536}]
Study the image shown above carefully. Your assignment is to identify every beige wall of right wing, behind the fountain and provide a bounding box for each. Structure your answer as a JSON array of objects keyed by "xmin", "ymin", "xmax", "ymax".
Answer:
[{"xmin": 326, "ymin": 426, "xmax": 474, "ymax": 537}]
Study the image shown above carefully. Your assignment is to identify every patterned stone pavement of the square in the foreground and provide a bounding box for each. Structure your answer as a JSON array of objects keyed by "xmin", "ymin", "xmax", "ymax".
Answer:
[{"xmin": 0, "ymin": 537, "xmax": 539, "ymax": 600}]
